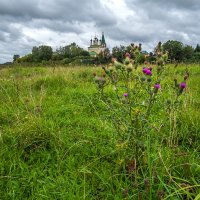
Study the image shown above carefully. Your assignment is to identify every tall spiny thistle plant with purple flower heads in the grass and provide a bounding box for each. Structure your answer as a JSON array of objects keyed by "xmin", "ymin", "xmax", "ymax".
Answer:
[{"xmin": 95, "ymin": 46, "xmax": 186, "ymax": 199}]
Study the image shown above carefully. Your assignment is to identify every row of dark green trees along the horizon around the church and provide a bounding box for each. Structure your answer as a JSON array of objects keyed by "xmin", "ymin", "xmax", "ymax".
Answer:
[{"xmin": 13, "ymin": 40, "xmax": 200, "ymax": 65}]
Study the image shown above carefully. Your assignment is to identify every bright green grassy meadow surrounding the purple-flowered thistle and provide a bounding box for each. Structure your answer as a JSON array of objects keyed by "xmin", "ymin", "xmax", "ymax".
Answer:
[{"xmin": 0, "ymin": 64, "xmax": 200, "ymax": 200}]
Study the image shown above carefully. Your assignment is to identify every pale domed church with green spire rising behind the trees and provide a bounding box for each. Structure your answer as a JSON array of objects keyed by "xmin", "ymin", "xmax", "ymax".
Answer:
[{"xmin": 88, "ymin": 33, "xmax": 106, "ymax": 57}]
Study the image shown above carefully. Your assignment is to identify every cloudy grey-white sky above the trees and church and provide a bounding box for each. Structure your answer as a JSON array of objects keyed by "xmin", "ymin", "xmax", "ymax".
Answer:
[{"xmin": 0, "ymin": 0, "xmax": 200, "ymax": 63}]
